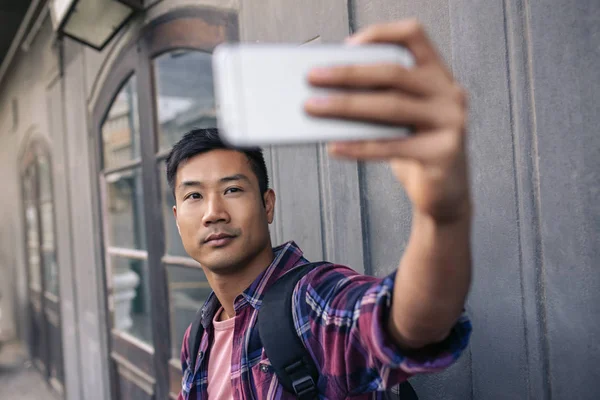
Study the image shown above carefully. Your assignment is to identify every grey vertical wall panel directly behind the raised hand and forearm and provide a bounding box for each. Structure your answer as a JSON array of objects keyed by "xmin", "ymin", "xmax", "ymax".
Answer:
[{"xmin": 351, "ymin": 0, "xmax": 472, "ymax": 400}]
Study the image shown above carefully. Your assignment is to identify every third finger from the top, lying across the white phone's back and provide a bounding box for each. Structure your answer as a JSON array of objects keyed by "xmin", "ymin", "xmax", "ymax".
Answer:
[{"xmin": 305, "ymin": 91, "xmax": 438, "ymax": 128}]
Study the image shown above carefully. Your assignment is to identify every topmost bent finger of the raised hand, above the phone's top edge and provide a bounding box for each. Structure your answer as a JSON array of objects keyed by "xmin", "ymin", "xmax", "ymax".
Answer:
[{"xmin": 348, "ymin": 19, "xmax": 441, "ymax": 70}]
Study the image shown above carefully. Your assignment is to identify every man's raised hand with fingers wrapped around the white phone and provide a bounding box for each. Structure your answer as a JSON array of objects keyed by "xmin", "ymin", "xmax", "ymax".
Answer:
[{"xmin": 306, "ymin": 20, "xmax": 471, "ymax": 226}]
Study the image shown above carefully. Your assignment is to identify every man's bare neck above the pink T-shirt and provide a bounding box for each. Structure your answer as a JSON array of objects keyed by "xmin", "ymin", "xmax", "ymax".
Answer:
[{"xmin": 203, "ymin": 246, "xmax": 274, "ymax": 321}]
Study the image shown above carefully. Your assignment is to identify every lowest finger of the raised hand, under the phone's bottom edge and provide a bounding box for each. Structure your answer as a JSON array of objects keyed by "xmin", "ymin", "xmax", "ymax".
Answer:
[{"xmin": 328, "ymin": 131, "xmax": 463, "ymax": 163}]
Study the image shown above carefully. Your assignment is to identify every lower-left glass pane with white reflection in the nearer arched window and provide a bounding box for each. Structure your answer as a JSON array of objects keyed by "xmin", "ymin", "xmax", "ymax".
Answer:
[{"xmin": 110, "ymin": 256, "xmax": 152, "ymax": 344}]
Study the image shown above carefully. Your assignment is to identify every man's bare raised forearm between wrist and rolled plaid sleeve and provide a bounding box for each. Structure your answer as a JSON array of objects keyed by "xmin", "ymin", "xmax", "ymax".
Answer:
[{"xmin": 389, "ymin": 207, "xmax": 471, "ymax": 348}]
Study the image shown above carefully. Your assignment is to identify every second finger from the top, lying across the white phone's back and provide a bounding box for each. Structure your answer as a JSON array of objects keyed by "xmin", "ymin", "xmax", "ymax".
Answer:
[{"xmin": 308, "ymin": 64, "xmax": 450, "ymax": 96}]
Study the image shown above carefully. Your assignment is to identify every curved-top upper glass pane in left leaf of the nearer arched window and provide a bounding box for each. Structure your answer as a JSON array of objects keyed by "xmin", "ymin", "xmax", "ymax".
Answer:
[{"xmin": 102, "ymin": 76, "xmax": 140, "ymax": 169}]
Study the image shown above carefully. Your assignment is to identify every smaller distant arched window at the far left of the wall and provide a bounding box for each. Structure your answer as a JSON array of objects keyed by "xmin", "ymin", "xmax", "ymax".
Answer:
[{"xmin": 20, "ymin": 137, "xmax": 64, "ymax": 394}]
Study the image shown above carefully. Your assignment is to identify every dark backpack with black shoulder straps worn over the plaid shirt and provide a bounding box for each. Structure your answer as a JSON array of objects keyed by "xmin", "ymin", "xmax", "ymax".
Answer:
[{"xmin": 188, "ymin": 263, "xmax": 418, "ymax": 400}]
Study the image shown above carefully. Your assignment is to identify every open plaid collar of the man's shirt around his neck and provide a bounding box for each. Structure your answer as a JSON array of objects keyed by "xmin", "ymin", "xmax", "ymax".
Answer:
[{"xmin": 202, "ymin": 241, "xmax": 308, "ymax": 329}]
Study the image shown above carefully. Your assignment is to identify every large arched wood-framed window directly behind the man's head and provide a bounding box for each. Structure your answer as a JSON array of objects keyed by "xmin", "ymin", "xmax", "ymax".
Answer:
[{"xmin": 93, "ymin": 8, "xmax": 238, "ymax": 399}]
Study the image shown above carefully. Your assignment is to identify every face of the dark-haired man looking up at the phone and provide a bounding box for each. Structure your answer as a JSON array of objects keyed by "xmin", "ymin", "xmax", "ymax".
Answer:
[{"xmin": 173, "ymin": 149, "xmax": 275, "ymax": 274}]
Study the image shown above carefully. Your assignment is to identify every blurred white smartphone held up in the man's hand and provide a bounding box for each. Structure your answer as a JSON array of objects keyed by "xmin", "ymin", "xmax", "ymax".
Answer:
[{"xmin": 212, "ymin": 43, "xmax": 414, "ymax": 146}]
